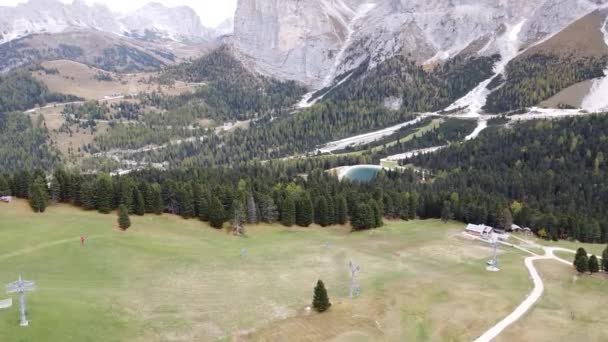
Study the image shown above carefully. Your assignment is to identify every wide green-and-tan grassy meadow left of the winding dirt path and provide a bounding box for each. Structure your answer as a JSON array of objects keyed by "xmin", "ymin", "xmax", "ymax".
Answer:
[{"xmin": 0, "ymin": 201, "xmax": 564, "ymax": 342}]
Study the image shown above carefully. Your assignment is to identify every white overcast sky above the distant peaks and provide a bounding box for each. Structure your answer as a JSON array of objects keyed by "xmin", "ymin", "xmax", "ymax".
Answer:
[{"xmin": 0, "ymin": 0, "xmax": 237, "ymax": 27}]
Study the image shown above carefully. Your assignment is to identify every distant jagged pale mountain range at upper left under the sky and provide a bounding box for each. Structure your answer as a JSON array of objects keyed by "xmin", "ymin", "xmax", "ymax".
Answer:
[{"xmin": 0, "ymin": 0, "xmax": 228, "ymax": 72}]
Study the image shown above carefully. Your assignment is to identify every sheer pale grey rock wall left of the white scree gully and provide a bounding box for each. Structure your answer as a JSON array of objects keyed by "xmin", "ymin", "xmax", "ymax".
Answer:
[{"xmin": 234, "ymin": 0, "xmax": 360, "ymax": 88}]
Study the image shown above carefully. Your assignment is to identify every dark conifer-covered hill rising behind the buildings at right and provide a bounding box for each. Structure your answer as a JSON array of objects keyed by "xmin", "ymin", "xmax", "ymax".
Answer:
[{"xmin": 406, "ymin": 115, "xmax": 608, "ymax": 242}]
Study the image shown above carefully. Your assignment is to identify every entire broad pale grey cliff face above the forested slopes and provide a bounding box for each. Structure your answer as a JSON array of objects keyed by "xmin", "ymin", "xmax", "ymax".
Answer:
[{"xmin": 234, "ymin": 0, "xmax": 608, "ymax": 88}]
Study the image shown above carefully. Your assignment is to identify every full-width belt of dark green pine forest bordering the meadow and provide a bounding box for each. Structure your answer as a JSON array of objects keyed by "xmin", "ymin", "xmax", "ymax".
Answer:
[{"xmin": 0, "ymin": 115, "xmax": 608, "ymax": 243}]
